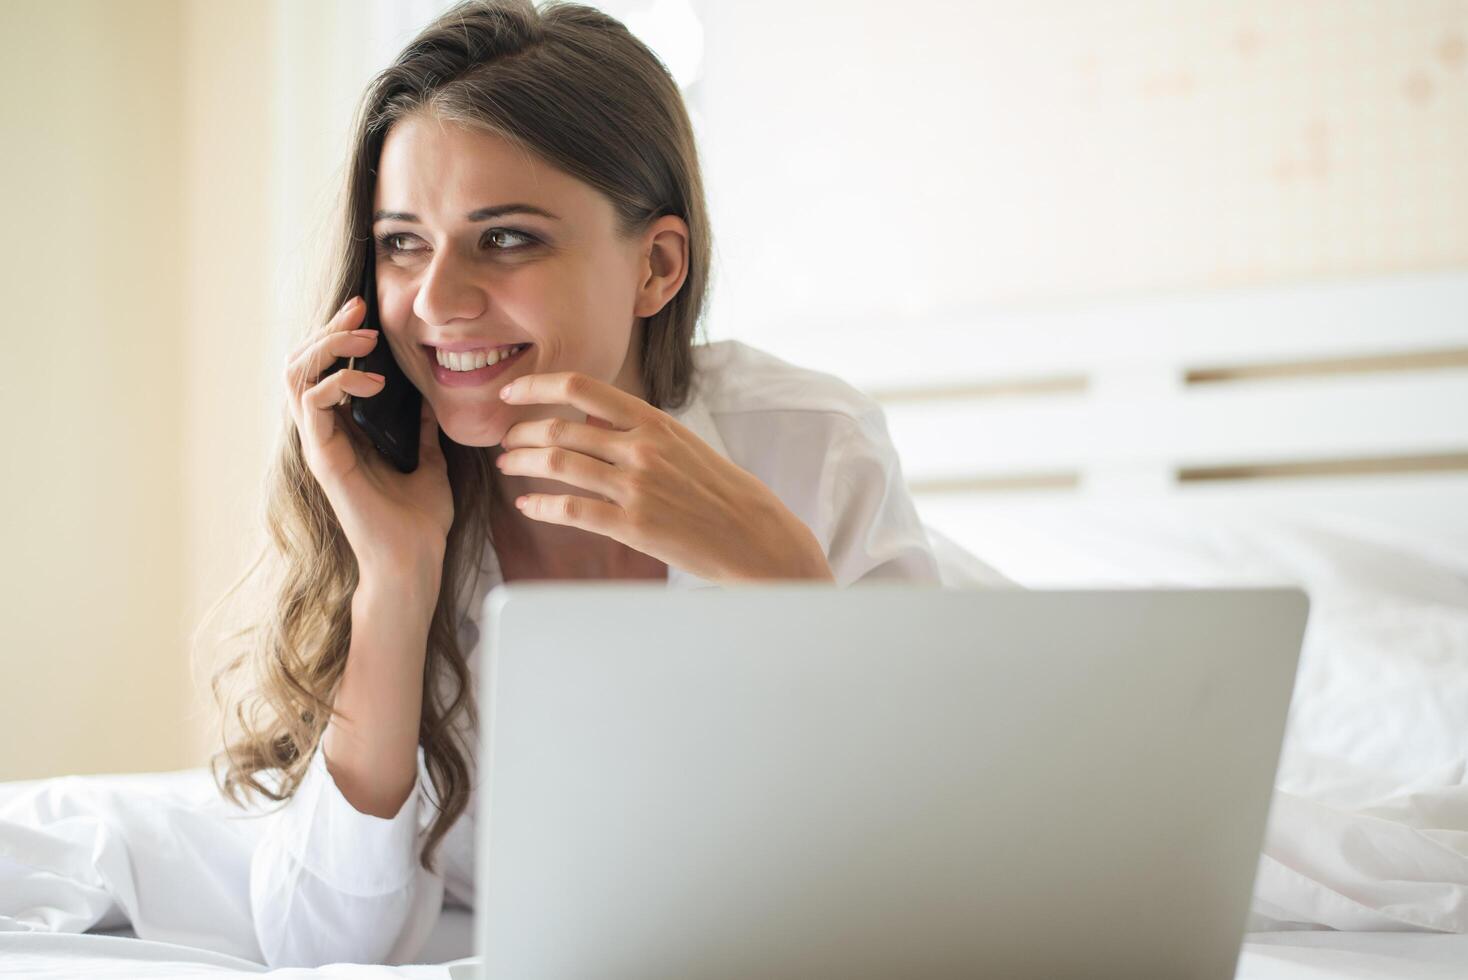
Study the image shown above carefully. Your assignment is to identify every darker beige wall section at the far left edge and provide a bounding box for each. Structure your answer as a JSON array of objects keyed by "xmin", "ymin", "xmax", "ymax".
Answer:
[{"xmin": 0, "ymin": 0, "xmax": 186, "ymax": 778}]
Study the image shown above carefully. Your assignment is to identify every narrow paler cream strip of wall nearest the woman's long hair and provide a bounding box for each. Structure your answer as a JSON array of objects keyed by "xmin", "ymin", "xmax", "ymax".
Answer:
[{"xmin": 179, "ymin": 0, "xmax": 283, "ymax": 766}]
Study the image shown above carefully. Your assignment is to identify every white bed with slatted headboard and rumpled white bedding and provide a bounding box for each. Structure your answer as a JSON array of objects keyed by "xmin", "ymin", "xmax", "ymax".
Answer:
[{"xmin": 0, "ymin": 274, "xmax": 1468, "ymax": 980}]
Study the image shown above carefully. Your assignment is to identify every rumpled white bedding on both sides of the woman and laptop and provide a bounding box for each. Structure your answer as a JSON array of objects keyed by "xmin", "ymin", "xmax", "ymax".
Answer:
[{"xmin": 0, "ymin": 508, "xmax": 1468, "ymax": 979}]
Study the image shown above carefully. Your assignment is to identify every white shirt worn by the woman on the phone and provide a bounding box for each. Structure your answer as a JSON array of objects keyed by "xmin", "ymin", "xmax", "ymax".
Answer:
[{"xmin": 250, "ymin": 340, "xmax": 940, "ymax": 967}]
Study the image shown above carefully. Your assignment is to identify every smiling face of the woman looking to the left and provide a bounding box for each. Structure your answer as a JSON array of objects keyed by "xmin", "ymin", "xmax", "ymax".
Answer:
[{"xmin": 373, "ymin": 114, "xmax": 661, "ymax": 446}]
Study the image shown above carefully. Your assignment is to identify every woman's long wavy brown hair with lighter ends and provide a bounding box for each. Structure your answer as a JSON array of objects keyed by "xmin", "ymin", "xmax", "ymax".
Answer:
[{"xmin": 197, "ymin": 0, "xmax": 711, "ymax": 871}]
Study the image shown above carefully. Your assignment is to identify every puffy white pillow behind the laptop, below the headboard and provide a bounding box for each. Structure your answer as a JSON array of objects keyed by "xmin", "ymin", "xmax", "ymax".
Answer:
[{"xmin": 954, "ymin": 500, "xmax": 1468, "ymax": 792}]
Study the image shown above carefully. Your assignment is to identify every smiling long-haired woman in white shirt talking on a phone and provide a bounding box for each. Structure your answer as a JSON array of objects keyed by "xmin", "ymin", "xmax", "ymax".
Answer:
[{"xmin": 216, "ymin": 0, "xmax": 938, "ymax": 965}]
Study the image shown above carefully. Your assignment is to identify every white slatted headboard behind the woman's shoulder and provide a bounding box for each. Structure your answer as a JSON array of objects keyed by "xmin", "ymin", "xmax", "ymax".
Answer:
[{"xmin": 766, "ymin": 273, "xmax": 1468, "ymax": 553}]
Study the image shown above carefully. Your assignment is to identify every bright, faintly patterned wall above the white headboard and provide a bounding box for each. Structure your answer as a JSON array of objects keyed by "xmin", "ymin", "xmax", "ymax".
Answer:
[{"xmin": 699, "ymin": 0, "xmax": 1468, "ymax": 342}]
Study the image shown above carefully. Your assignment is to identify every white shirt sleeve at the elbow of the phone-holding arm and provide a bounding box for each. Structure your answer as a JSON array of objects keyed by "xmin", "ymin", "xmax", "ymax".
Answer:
[{"xmin": 250, "ymin": 745, "xmax": 443, "ymax": 967}]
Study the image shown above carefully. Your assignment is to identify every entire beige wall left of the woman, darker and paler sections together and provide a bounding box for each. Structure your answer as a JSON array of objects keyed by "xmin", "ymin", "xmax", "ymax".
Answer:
[{"xmin": 0, "ymin": 0, "xmax": 269, "ymax": 779}]
